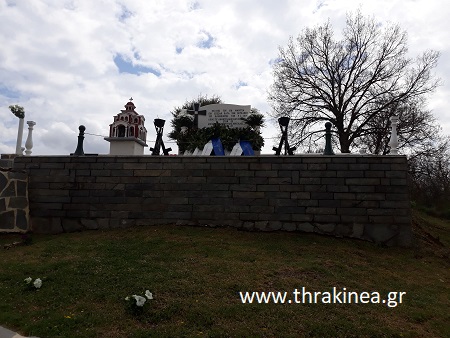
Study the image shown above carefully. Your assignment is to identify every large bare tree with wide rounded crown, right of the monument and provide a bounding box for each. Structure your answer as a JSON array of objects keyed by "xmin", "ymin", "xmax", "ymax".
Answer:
[{"xmin": 269, "ymin": 12, "xmax": 439, "ymax": 153}]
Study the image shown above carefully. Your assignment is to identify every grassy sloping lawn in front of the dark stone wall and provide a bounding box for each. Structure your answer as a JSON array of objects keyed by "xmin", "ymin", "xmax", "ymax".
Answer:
[{"xmin": 0, "ymin": 212, "xmax": 450, "ymax": 338}]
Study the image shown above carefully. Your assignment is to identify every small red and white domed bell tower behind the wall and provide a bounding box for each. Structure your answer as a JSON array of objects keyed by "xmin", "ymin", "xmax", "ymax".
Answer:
[{"xmin": 105, "ymin": 98, "xmax": 147, "ymax": 155}]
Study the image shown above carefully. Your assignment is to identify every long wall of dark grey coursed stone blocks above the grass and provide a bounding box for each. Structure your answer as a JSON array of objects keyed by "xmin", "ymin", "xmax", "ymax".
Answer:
[{"xmin": 15, "ymin": 155, "xmax": 412, "ymax": 245}]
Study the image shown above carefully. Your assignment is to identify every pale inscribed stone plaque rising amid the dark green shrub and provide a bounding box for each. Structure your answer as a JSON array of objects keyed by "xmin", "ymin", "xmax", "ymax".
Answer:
[{"xmin": 198, "ymin": 103, "xmax": 251, "ymax": 128}]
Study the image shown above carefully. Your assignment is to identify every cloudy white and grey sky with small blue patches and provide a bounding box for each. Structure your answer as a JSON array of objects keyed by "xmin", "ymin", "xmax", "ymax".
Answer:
[{"xmin": 0, "ymin": 0, "xmax": 450, "ymax": 155}]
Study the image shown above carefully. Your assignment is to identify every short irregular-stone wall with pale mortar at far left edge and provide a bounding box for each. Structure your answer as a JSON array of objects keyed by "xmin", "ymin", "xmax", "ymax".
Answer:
[{"xmin": 0, "ymin": 168, "xmax": 29, "ymax": 232}]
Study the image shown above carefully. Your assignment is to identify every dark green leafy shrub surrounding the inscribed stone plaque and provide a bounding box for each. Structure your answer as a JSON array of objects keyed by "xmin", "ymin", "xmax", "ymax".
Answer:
[{"xmin": 168, "ymin": 95, "xmax": 264, "ymax": 152}]
